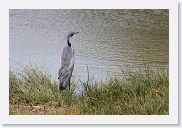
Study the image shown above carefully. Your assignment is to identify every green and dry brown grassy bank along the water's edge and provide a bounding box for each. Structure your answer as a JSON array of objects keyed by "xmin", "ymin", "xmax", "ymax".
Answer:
[{"xmin": 9, "ymin": 67, "xmax": 169, "ymax": 115}]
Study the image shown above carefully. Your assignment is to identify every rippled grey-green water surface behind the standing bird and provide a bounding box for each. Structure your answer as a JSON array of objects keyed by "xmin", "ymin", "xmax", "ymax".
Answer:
[{"xmin": 9, "ymin": 9, "xmax": 169, "ymax": 80}]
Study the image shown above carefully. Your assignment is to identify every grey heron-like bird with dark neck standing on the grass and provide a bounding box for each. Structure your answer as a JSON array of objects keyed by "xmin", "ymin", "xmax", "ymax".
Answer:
[{"xmin": 58, "ymin": 32, "xmax": 79, "ymax": 91}]
